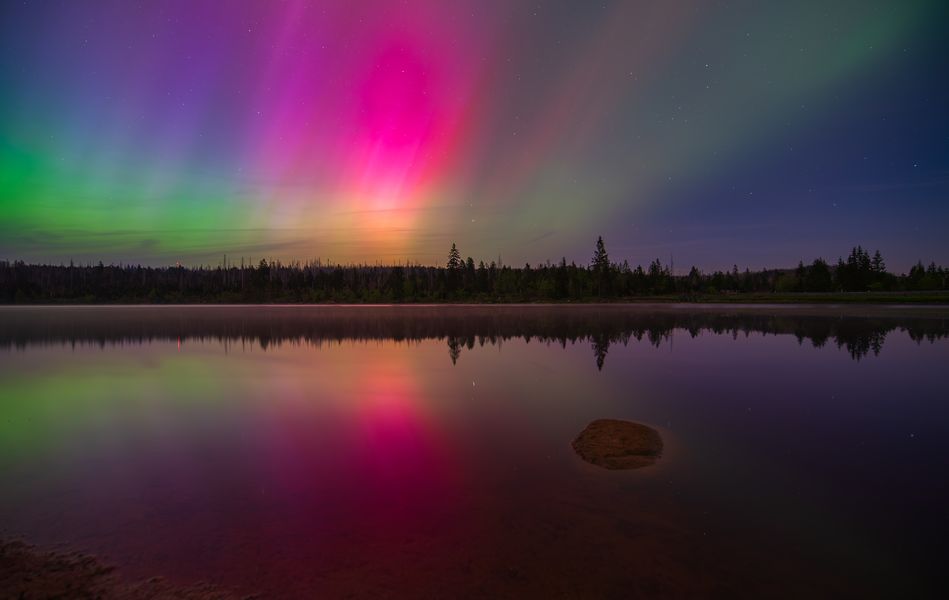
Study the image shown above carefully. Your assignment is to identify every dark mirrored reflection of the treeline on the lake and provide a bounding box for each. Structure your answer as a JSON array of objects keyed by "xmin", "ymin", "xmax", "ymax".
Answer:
[{"xmin": 0, "ymin": 305, "xmax": 949, "ymax": 369}]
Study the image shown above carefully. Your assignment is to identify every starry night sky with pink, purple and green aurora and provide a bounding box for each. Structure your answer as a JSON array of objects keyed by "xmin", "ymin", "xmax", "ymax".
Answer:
[{"xmin": 0, "ymin": 0, "xmax": 949, "ymax": 271}]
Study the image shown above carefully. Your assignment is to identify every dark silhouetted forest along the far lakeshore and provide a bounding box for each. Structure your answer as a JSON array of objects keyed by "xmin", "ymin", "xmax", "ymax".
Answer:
[{"xmin": 0, "ymin": 237, "xmax": 949, "ymax": 304}]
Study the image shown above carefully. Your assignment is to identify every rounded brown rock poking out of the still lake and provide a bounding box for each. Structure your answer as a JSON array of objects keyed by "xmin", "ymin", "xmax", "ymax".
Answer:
[{"xmin": 573, "ymin": 419, "xmax": 662, "ymax": 469}]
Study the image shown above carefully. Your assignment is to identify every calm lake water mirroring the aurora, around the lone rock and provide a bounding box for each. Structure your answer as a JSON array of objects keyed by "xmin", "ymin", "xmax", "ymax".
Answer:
[{"xmin": 0, "ymin": 306, "xmax": 949, "ymax": 598}]
